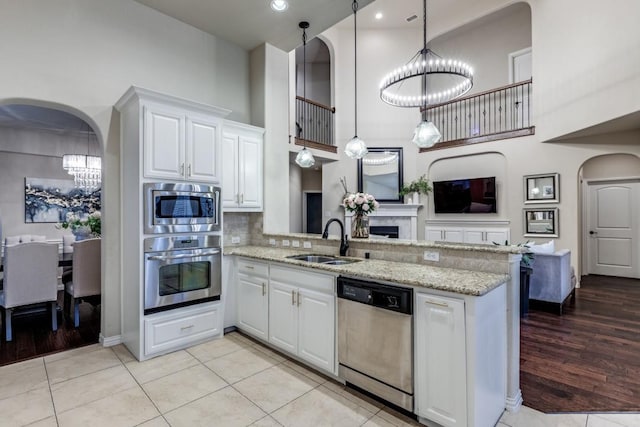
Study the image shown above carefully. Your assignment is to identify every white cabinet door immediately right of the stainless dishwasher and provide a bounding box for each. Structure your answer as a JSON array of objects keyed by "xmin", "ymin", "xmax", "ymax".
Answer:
[{"xmin": 415, "ymin": 293, "xmax": 467, "ymax": 427}]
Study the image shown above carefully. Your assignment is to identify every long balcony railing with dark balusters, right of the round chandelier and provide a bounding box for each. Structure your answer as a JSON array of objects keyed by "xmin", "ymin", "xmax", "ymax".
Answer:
[{"xmin": 420, "ymin": 79, "xmax": 535, "ymax": 152}]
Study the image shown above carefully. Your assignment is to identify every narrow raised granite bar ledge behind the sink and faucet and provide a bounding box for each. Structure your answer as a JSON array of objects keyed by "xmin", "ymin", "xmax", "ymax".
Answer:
[{"xmin": 264, "ymin": 233, "xmax": 528, "ymax": 254}]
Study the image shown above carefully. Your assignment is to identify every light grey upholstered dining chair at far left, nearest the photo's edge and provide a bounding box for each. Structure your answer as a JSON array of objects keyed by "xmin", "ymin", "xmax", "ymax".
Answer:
[{"xmin": 0, "ymin": 242, "xmax": 58, "ymax": 341}]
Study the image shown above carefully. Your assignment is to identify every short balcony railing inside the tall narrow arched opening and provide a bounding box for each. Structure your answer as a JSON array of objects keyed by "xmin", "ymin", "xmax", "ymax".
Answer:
[{"xmin": 296, "ymin": 96, "xmax": 336, "ymax": 152}]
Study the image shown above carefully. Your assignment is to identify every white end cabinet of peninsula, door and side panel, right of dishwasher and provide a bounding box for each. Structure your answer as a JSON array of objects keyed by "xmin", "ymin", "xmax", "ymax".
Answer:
[{"xmin": 414, "ymin": 284, "xmax": 507, "ymax": 427}]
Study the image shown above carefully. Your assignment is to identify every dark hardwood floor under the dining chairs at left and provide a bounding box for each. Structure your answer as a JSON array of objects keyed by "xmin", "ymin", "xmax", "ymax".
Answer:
[{"xmin": 0, "ymin": 291, "xmax": 100, "ymax": 366}]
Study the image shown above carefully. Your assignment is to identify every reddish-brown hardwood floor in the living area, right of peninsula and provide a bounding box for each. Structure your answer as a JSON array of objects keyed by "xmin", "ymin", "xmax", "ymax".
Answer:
[{"xmin": 520, "ymin": 276, "xmax": 640, "ymax": 413}]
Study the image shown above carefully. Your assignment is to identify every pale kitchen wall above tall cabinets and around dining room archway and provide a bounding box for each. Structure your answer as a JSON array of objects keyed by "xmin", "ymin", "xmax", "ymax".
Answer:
[{"xmin": 0, "ymin": 0, "xmax": 254, "ymax": 337}]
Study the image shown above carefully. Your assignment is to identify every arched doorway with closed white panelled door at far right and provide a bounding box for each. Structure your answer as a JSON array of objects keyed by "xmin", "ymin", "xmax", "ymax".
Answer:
[{"xmin": 580, "ymin": 154, "xmax": 640, "ymax": 278}]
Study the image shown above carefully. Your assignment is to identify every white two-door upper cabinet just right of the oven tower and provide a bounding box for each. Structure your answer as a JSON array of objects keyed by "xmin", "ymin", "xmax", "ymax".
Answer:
[{"xmin": 222, "ymin": 120, "xmax": 264, "ymax": 212}]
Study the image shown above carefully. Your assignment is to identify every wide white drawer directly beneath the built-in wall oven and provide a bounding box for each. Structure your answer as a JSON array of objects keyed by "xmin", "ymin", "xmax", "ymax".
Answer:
[{"xmin": 144, "ymin": 303, "xmax": 221, "ymax": 355}]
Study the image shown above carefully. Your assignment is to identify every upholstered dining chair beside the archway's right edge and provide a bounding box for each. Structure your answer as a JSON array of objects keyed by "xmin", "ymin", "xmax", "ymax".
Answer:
[{"xmin": 63, "ymin": 238, "xmax": 101, "ymax": 328}]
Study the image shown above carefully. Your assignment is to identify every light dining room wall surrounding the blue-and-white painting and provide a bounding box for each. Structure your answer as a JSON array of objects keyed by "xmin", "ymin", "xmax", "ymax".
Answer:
[{"xmin": 0, "ymin": 127, "xmax": 99, "ymax": 239}]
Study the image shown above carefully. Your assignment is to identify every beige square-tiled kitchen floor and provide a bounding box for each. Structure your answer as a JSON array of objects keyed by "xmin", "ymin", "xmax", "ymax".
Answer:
[{"xmin": 0, "ymin": 333, "xmax": 640, "ymax": 427}]
